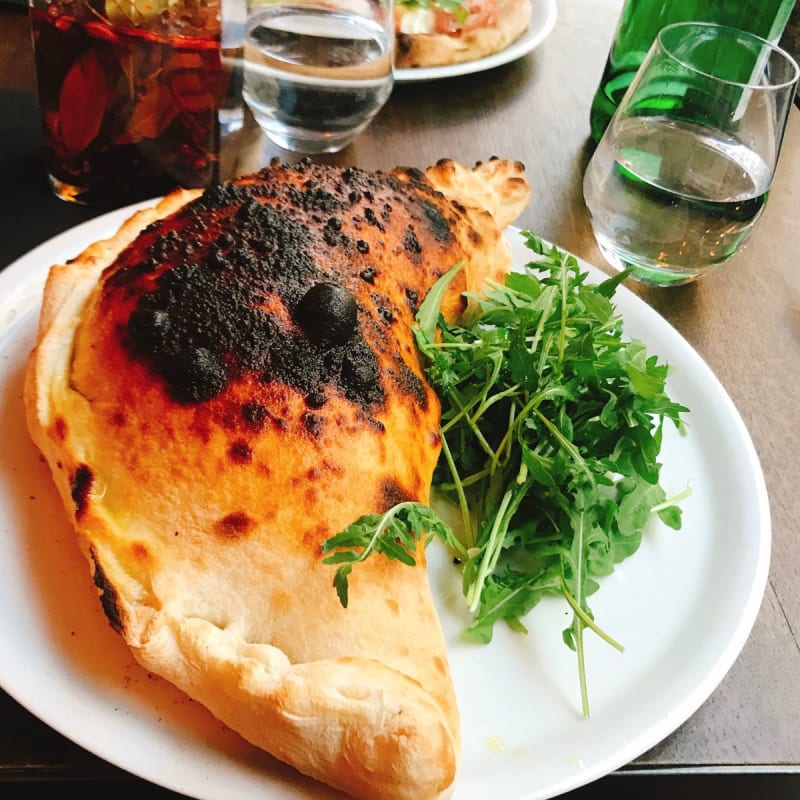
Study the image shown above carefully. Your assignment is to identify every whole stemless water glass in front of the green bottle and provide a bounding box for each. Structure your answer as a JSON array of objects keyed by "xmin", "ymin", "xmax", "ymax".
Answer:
[{"xmin": 583, "ymin": 22, "xmax": 798, "ymax": 286}]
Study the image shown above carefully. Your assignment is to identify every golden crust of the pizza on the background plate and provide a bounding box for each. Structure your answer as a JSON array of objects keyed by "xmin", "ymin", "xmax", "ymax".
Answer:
[{"xmin": 394, "ymin": 0, "xmax": 531, "ymax": 69}]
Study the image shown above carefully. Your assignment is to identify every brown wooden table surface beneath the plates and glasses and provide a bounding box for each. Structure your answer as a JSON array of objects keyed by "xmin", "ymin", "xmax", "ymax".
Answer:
[{"xmin": 0, "ymin": 0, "xmax": 800, "ymax": 798}]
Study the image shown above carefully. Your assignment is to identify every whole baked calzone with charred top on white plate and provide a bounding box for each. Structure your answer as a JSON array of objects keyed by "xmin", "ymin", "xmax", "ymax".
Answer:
[{"xmin": 25, "ymin": 159, "xmax": 530, "ymax": 800}]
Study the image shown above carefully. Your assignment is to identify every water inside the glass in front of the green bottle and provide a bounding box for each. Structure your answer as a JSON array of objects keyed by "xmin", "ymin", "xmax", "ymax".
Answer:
[{"xmin": 584, "ymin": 117, "xmax": 772, "ymax": 284}]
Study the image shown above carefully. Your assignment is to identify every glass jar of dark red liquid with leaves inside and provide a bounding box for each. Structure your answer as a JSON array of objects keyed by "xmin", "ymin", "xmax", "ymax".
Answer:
[{"xmin": 29, "ymin": 0, "xmax": 245, "ymax": 207}]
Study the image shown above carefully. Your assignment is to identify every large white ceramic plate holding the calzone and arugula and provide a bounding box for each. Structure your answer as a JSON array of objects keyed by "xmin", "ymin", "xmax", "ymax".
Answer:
[{"xmin": 0, "ymin": 209, "xmax": 770, "ymax": 800}]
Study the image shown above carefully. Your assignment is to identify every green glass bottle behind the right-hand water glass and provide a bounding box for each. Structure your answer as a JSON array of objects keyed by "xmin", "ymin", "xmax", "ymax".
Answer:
[{"xmin": 590, "ymin": 0, "xmax": 795, "ymax": 142}]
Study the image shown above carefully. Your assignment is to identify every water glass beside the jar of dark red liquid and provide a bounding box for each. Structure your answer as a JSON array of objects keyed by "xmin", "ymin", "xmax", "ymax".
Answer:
[{"xmin": 243, "ymin": 0, "xmax": 394, "ymax": 153}]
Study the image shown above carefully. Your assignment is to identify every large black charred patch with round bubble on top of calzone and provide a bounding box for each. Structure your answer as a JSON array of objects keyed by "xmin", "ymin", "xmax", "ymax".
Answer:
[{"xmin": 121, "ymin": 174, "xmax": 396, "ymax": 412}]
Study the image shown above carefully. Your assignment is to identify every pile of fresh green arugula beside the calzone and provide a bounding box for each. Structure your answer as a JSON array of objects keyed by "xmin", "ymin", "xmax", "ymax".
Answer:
[{"xmin": 323, "ymin": 231, "xmax": 689, "ymax": 717}]
